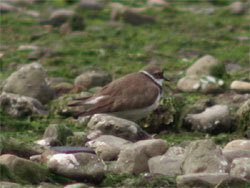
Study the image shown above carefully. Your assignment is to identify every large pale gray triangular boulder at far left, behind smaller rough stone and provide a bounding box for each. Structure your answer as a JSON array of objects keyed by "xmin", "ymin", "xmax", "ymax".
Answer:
[{"xmin": 3, "ymin": 63, "xmax": 54, "ymax": 103}]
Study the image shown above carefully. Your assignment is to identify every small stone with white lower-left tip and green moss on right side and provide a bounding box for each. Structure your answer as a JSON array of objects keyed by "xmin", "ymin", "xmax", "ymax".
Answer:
[{"xmin": 35, "ymin": 124, "xmax": 73, "ymax": 147}]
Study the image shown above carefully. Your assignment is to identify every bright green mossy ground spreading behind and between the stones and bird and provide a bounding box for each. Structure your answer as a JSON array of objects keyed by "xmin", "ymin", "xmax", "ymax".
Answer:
[{"xmin": 0, "ymin": 0, "xmax": 250, "ymax": 185}]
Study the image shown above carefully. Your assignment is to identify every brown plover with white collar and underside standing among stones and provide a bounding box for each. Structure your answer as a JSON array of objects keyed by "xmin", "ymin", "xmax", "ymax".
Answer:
[{"xmin": 68, "ymin": 66, "xmax": 169, "ymax": 121}]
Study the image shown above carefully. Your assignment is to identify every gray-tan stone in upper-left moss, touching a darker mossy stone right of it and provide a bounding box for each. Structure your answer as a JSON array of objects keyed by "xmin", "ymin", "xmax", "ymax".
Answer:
[{"xmin": 49, "ymin": 9, "xmax": 75, "ymax": 26}]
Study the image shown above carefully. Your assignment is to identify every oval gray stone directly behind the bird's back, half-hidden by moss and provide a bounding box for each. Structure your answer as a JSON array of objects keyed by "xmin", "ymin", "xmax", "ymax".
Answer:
[{"xmin": 74, "ymin": 70, "xmax": 111, "ymax": 89}]
